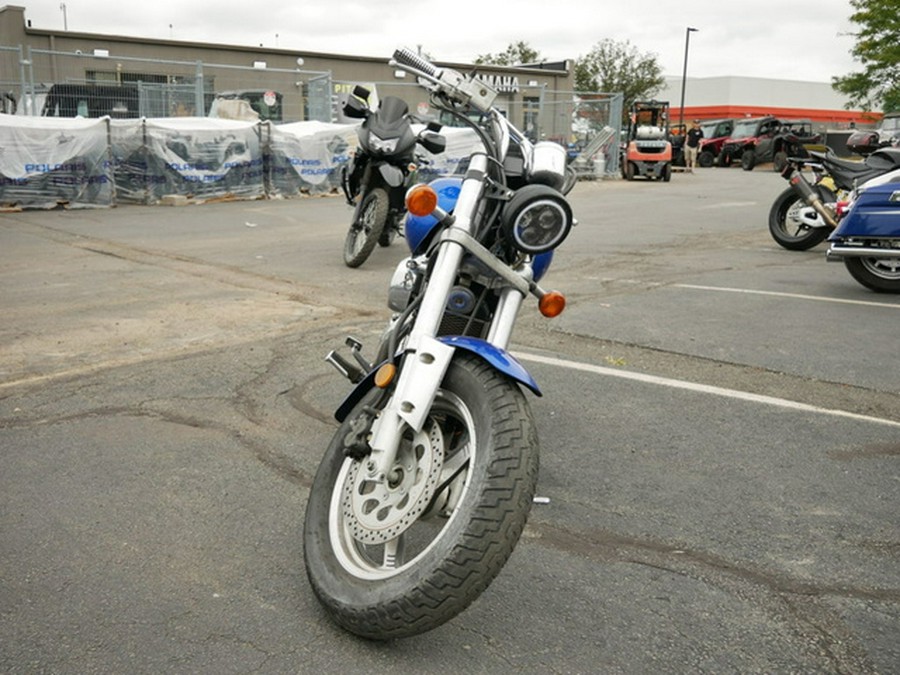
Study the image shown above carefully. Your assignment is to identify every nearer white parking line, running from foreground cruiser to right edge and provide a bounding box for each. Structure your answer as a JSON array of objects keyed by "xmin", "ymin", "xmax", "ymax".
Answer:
[{"xmin": 513, "ymin": 352, "xmax": 900, "ymax": 428}]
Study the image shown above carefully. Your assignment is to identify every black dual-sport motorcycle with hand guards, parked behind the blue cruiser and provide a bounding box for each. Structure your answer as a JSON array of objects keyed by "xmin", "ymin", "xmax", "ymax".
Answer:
[{"xmin": 341, "ymin": 85, "xmax": 446, "ymax": 267}]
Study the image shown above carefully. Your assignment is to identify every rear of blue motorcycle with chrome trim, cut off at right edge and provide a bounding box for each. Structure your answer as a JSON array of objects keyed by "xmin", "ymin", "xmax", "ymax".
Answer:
[{"xmin": 827, "ymin": 169, "xmax": 900, "ymax": 293}]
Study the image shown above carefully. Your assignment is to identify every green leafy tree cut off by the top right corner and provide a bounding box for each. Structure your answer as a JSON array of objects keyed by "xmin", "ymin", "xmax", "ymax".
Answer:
[{"xmin": 831, "ymin": 0, "xmax": 900, "ymax": 112}]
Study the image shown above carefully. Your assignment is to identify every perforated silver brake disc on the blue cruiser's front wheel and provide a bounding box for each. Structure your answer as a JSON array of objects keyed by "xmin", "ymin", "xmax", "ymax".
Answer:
[{"xmin": 341, "ymin": 420, "xmax": 444, "ymax": 544}]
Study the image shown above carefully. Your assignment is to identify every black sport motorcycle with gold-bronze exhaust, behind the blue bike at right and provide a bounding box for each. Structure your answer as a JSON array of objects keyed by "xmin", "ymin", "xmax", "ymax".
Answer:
[{"xmin": 769, "ymin": 148, "xmax": 900, "ymax": 251}]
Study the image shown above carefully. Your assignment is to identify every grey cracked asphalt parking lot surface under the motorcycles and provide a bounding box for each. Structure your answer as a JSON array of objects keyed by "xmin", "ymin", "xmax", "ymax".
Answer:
[{"xmin": 0, "ymin": 167, "xmax": 900, "ymax": 673}]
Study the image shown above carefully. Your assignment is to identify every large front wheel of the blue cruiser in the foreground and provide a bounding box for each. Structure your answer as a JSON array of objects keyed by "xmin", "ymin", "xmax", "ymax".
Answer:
[{"xmin": 303, "ymin": 355, "xmax": 538, "ymax": 640}]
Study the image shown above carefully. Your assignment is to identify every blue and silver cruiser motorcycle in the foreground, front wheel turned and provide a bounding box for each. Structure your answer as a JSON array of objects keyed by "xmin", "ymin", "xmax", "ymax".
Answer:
[{"xmin": 303, "ymin": 49, "xmax": 574, "ymax": 639}]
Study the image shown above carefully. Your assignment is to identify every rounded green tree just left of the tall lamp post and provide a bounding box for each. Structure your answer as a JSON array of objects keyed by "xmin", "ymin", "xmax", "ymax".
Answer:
[{"xmin": 575, "ymin": 38, "xmax": 665, "ymax": 108}]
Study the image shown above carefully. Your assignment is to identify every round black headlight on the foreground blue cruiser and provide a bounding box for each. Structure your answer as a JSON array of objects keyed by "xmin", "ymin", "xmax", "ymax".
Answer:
[{"xmin": 500, "ymin": 185, "xmax": 572, "ymax": 254}]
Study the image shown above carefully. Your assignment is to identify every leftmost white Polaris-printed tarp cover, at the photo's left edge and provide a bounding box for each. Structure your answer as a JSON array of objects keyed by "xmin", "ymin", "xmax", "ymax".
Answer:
[{"xmin": 0, "ymin": 114, "xmax": 114, "ymax": 208}]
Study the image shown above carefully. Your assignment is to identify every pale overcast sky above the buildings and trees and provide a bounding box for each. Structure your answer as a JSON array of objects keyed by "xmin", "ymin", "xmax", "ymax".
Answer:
[{"xmin": 26, "ymin": 0, "xmax": 860, "ymax": 82}]
